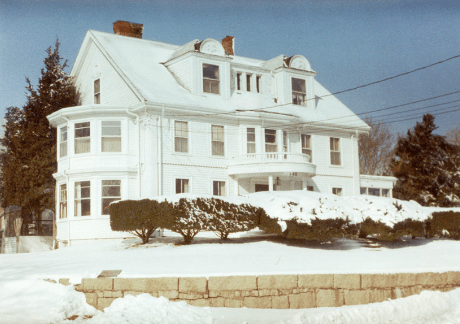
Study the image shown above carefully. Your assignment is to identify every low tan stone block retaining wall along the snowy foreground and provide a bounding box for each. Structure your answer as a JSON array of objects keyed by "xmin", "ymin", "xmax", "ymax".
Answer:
[{"xmin": 59, "ymin": 272, "xmax": 460, "ymax": 310}]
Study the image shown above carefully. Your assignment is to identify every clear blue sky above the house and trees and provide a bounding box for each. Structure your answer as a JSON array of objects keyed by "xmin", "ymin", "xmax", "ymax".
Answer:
[{"xmin": 0, "ymin": 0, "xmax": 460, "ymax": 134}]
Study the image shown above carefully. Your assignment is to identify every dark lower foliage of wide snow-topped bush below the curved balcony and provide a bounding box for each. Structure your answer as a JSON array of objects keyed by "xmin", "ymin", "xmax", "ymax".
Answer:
[{"xmin": 283, "ymin": 218, "xmax": 350, "ymax": 241}]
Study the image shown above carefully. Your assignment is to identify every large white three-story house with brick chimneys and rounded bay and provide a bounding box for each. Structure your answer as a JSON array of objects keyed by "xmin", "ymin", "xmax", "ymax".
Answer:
[{"xmin": 48, "ymin": 21, "xmax": 391, "ymax": 246}]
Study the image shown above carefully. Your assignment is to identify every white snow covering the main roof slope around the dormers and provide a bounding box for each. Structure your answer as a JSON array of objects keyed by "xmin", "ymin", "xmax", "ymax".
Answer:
[{"xmin": 88, "ymin": 30, "xmax": 369, "ymax": 131}]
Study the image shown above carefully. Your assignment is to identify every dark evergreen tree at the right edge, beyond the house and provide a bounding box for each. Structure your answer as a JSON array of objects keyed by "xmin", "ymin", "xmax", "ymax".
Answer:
[{"xmin": 392, "ymin": 114, "xmax": 460, "ymax": 206}]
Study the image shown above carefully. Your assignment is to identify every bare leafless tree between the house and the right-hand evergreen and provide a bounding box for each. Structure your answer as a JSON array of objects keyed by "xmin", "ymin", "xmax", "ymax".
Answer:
[{"xmin": 358, "ymin": 117, "xmax": 396, "ymax": 175}]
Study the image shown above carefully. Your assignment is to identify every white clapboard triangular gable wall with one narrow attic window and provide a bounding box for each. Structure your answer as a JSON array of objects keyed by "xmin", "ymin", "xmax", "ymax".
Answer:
[{"xmin": 75, "ymin": 43, "xmax": 140, "ymax": 106}]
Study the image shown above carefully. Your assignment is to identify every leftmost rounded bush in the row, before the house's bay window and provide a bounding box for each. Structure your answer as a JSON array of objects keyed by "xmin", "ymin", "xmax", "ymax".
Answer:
[{"xmin": 109, "ymin": 199, "xmax": 163, "ymax": 244}]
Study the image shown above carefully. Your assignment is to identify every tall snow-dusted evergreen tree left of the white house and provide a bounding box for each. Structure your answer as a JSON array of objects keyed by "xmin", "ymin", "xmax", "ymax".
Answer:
[{"xmin": 0, "ymin": 40, "xmax": 79, "ymax": 228}]
